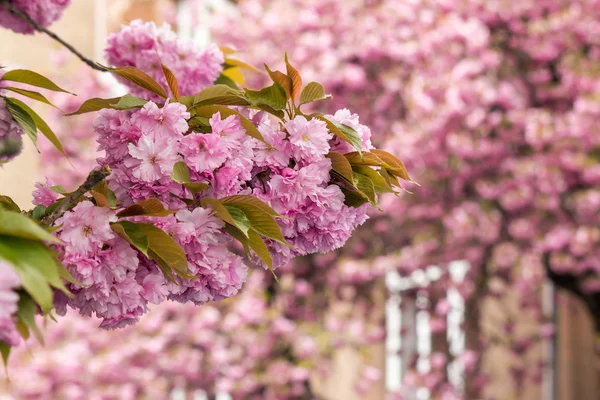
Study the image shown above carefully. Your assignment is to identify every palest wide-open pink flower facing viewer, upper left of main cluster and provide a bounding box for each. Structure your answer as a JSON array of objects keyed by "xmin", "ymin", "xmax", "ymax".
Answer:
[{"xmin": 125, "ymin": 136, "xmax": 179, "ymax": 182}]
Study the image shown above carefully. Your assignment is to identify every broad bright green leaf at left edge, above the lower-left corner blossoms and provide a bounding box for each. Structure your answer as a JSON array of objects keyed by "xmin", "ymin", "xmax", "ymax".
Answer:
[{"xmin": 0, "ymin": 236, "xmax": 62, "ymax": 314}]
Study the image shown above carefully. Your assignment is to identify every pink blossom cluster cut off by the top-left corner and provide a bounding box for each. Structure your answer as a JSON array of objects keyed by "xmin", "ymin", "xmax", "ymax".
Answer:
[{"xmin": 0, "ymin": 0, "xmax": 71, "ymax": 35}]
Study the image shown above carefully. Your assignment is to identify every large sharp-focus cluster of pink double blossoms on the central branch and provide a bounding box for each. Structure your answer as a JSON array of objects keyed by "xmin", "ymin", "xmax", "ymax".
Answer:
[{"xmin": 57, "ymin": 98, "xmax": 368, "ymax": 327}]
